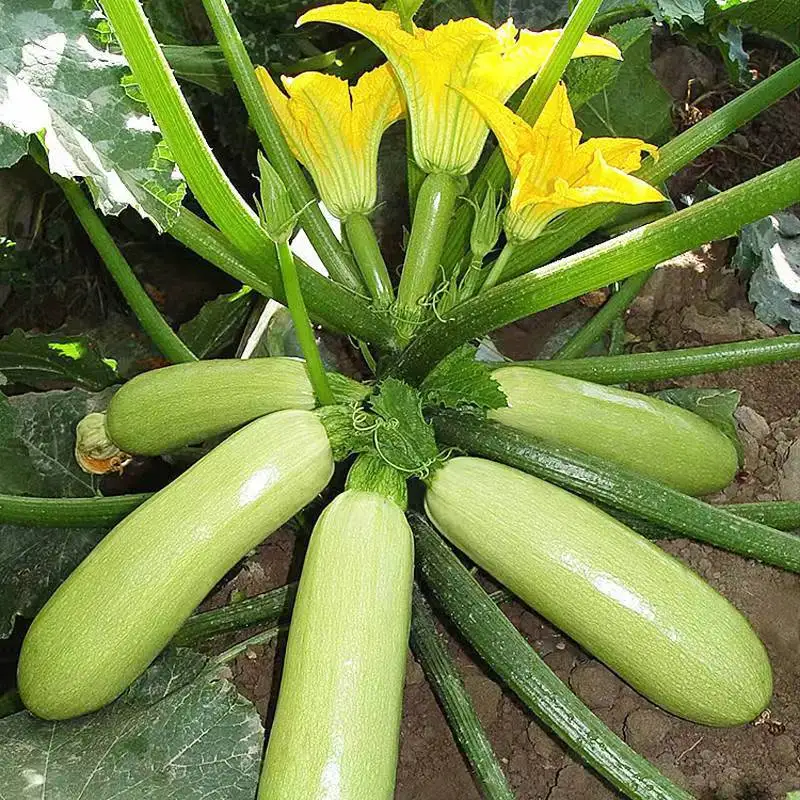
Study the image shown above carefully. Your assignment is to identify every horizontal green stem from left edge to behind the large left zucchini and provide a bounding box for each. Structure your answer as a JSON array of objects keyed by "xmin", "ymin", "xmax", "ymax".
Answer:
[{"xmin": 0, "ymin": 493, "xmax": 151, "ymax": 528}]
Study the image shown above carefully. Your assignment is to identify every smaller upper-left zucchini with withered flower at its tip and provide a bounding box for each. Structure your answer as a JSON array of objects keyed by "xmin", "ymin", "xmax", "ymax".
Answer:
[{"xmin": 106, "ymin": 357, "xmax": 365, "ymax": 456}]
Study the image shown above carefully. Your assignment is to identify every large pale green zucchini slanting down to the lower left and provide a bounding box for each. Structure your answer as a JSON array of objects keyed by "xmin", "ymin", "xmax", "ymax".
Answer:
[{"xmin": 18, "ymin": 411, "xmax": 334, "ymax": 719}]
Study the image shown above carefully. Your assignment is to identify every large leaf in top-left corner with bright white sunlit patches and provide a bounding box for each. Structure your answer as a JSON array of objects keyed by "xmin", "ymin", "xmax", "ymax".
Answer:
[{"xmin": 0, "ymin": 0, "xmax": 185, "ymax": 228}]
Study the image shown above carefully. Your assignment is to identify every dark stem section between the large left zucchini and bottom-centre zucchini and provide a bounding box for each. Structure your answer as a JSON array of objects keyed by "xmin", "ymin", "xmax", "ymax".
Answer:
[{"xmin": 172, "ymin": 583, "xmax": 297, "ymax": 646}]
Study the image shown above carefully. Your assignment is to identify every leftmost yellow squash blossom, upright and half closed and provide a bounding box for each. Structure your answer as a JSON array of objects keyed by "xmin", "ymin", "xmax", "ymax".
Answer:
[{"xmin": 256, "ymin": 65, "xmax": 404, "ymax": 219}]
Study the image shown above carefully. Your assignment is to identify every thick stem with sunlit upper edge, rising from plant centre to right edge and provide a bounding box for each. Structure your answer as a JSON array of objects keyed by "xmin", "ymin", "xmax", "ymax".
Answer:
[{"xmin": 393, "ymin": 158, "xmax": 800, "ymax": 381}]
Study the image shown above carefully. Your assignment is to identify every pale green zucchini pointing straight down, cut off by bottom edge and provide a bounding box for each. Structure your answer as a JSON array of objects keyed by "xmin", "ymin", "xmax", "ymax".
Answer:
[{"xmin": 258, "ymin": 490, "xmax": 414, "ymax": 800}]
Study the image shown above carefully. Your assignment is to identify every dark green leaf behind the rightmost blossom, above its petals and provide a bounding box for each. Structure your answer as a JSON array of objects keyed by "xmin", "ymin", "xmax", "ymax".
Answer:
[{"xmin": 575, "ymin": 23, "xmax": 672, "ymax": 144}]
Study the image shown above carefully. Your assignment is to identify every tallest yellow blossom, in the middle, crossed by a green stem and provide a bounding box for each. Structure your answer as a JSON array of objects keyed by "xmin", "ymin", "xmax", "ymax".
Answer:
[{"xmin": 298, "ymin": 2, "xmax": 621, "ymax": 175}]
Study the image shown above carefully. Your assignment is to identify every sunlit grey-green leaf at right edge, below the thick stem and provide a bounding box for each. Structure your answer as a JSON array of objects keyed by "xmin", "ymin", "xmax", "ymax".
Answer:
[{"xmin": 731, "ymin": 213, "xmax": 800, "ymax": 333}]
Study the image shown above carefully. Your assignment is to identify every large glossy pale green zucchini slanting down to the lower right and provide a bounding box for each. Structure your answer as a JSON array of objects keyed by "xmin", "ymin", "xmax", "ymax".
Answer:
[{"xmin": 425, "ymin": 458, "xmax": 772, "ymax": 726}]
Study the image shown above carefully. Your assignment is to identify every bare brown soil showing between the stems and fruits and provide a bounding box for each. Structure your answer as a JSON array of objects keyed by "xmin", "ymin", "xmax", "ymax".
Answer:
[{"xmin": 194, "ymin": 42, "xmax": 800, "ymax": 800}]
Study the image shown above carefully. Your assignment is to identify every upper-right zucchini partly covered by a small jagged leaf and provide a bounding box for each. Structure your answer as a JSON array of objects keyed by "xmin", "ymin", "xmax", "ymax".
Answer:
[{"xmin": 489, "ymin": 367, "xmax": 738, "ymax": 495}]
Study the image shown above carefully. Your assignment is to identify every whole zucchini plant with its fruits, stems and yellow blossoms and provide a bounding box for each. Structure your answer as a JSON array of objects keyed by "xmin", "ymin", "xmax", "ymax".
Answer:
[{"xmin": 0, "ymin": 0, "xmax": 800, "ymax": 800}]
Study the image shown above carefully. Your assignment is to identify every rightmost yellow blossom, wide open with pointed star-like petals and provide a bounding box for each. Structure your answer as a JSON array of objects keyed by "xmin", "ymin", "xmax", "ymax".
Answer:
[{"xmin": 462, "ymin": 83, "xmax": 665, "ymax": 241}]
